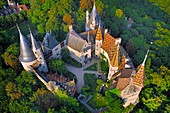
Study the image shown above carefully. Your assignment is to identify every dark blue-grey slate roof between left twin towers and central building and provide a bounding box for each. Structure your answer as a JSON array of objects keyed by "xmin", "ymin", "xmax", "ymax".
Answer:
[{"xmin": 42, "ymin": 32, "xmax": 59, "ymax": 49}]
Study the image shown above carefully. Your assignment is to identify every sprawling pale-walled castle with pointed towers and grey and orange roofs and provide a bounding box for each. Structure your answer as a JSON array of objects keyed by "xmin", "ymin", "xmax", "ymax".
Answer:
[{"xmin": 18, "ymin": 4, "xmax": 149, "ymax": 107}]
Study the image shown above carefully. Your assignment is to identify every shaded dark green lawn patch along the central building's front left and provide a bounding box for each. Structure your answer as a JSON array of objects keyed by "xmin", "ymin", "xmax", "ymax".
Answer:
[{"xmin": 62, "ymin": 56, "xmax": 82, "ymax": 67}]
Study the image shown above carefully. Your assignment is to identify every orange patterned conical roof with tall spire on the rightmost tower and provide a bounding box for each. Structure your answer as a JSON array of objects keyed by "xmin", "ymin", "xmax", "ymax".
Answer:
[{"xmin": 133, "ymin": 50, "xmax": 149, "ymax": 87}]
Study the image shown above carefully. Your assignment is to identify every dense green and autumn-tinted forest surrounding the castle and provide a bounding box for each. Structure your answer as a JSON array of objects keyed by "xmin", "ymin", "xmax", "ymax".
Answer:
[{"xmin": 0, "ymin": 0, "xmax": 170, "ymax": 113}]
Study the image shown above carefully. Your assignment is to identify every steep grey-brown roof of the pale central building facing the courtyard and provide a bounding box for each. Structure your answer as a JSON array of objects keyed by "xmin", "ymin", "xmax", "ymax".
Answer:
[{"xmin": 67, "ymin": 30, "xmax": 86, "ymax": 52}]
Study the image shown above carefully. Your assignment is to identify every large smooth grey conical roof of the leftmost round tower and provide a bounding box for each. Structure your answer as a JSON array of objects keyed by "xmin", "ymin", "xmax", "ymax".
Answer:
[{"xmin": 18, "ymin": 27, "xmax": 36, "ymax": 62}]
